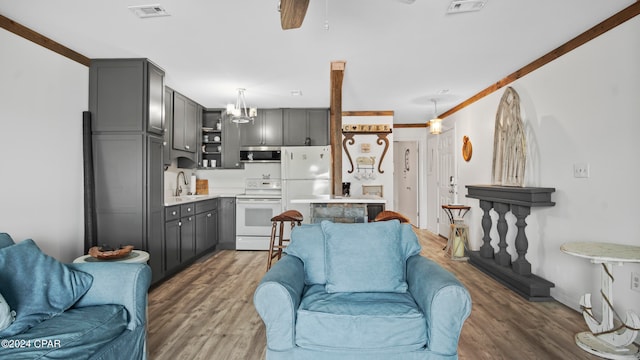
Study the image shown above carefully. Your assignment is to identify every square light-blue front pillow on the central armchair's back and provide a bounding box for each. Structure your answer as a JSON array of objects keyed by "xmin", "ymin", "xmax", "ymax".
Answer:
[{"xmin": 321, "ymin": 220, "xmax": 407, "ymax": 293}]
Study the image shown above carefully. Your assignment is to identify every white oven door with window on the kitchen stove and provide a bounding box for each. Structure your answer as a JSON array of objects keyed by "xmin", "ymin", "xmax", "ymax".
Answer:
[{"xmin": 236, "ymin": 198, "xmax": 282, "ymax": 237}]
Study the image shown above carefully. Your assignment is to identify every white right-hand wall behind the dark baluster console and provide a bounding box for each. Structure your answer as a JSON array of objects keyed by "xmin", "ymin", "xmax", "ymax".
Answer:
[{"xmin": 440, "ymin": 17, "xmax": 640, "ymax": 322}]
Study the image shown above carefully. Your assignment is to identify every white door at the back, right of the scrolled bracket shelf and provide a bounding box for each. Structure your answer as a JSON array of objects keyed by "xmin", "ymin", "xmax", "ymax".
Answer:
[{"xmin": 393, "ymin": 141, "xmax": 420, "ymax": 226}]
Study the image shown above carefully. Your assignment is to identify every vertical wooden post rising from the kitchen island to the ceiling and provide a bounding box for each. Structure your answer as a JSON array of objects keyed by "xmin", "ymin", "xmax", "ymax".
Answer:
[{"xmin": 329, "ymin": 61, "xmax": 346, "ymax": 195}]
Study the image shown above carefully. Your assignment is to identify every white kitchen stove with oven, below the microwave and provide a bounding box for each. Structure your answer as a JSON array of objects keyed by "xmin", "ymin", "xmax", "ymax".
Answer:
[{"xmin": 236, "ymin": 179, "xmax": 282, "ymax": 250}]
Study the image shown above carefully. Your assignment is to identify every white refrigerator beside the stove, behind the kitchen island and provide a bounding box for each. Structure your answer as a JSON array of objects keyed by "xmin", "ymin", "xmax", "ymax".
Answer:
[{"xmin": 280, "ymin": 146, "xmax": 331, "ymax": 223}]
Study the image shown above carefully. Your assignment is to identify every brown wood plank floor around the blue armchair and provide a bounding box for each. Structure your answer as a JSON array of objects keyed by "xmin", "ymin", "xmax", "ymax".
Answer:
[{"xmin": 148, "ymin": 230, "xmax": 599, "ymax": 360}]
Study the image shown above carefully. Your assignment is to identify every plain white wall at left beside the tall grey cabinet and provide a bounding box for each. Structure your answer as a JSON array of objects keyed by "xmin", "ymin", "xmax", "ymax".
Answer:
[{"xmin": 0, "ymin": 29, "xmax": 89, "ymax": 261}]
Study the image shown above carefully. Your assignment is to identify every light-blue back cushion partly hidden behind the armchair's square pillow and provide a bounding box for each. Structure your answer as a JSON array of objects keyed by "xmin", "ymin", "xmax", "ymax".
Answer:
[{"xmin": 284, "ymin": 224, "xmax": 327, "ymax": 285}]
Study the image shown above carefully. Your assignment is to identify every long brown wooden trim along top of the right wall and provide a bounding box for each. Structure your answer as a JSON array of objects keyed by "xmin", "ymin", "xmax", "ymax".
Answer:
[{"xmin": 438, "ymin": 1, "xmax": 640, "ymax": 119}]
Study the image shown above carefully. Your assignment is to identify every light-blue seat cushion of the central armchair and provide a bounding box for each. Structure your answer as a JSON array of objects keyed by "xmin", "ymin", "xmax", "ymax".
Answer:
[{"xmin": 295, "ymin": 285, "xmax": 427, "ymax": 352}]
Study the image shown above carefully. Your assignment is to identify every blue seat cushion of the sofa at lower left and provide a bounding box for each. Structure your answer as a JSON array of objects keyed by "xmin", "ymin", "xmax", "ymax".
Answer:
[{"xmin": 0, "ymin": 305, "xmax": 127, "ymax": 359}]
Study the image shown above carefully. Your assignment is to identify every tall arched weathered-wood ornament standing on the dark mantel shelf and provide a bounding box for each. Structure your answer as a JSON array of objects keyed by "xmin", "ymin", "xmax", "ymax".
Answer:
[{"xmin": 491, "ymin": 87, "xmax": 527, "ymax": 187}]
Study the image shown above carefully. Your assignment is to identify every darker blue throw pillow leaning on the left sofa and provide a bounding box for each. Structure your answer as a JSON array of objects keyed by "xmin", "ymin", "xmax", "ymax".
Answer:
[{"xmin": 0, "ymin": 239, "xmax": 93, "ymax": 338}]
